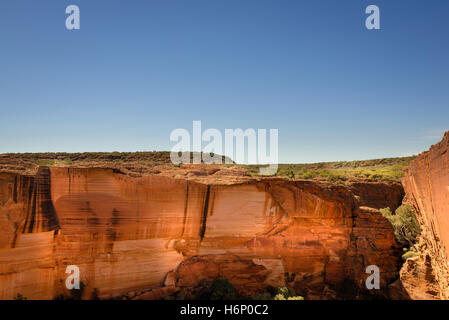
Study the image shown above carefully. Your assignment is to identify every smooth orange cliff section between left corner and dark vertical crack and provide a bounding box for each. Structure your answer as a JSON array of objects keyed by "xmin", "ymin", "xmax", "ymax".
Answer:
[{"xmin": 51, "ymin": 168, "xmax": 207, "ymax": 297}]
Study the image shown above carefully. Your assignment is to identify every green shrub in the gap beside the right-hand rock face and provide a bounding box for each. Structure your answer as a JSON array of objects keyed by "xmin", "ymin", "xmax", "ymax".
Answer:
[{"xmin": 380, "ymin": 205, "xmax": 420, "ymax": 247}]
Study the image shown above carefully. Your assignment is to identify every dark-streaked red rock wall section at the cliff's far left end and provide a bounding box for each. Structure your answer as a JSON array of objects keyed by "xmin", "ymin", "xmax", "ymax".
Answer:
[{"xmin": 0, "ymin": 168, "xmax": 59, "ymax": 299}]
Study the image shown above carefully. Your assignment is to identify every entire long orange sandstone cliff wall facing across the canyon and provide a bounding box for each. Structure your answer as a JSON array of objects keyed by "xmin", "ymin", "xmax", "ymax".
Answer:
[{"xmin": 0, "ymin": 167, "xmax": 405, "ymax": 299}]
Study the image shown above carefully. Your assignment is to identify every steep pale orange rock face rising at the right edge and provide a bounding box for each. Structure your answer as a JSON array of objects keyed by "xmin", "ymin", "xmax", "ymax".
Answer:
[{"xmin": 403, "ymin": 132, "xmax": 449, "ymax": 299}]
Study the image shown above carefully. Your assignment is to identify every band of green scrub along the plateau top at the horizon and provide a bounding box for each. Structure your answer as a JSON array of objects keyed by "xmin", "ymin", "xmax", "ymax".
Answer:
[{"xmin": 0, "ymin": 151, "xmax": 415, "ymax": 184}]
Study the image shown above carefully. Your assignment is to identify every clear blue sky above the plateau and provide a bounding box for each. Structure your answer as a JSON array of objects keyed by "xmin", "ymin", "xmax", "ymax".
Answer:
[{"xmin": 0, "ymin": 0, "xmax": 449, "ymax": 163}]
